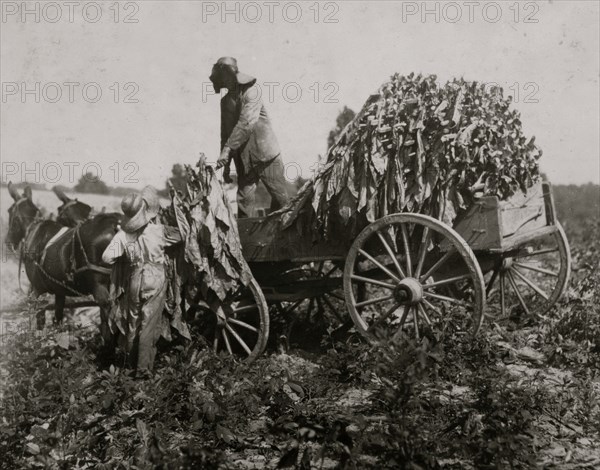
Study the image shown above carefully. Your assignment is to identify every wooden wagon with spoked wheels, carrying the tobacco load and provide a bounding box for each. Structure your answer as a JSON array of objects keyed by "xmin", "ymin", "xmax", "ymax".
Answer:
[{"xmin": 198, "ymin": 183, "xmax": 571, "ymax": 360}]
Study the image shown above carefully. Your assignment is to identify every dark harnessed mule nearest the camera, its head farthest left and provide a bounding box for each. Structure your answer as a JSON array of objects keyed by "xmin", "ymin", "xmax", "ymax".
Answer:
[{"xmin": 6, "ymin": 183, "xmax": 122, "ymax": 341}]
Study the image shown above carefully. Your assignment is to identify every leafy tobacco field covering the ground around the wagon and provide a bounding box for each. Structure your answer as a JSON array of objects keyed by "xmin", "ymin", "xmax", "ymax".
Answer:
[{"xmin": 0, "ymin": 186, "xmax": 600, "ymax": 469}]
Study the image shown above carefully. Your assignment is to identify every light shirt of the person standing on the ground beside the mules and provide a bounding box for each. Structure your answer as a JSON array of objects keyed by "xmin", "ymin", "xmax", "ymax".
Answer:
[{"xmin": 102, "ymin": 224, "xmax": 181, "ymax": 264}]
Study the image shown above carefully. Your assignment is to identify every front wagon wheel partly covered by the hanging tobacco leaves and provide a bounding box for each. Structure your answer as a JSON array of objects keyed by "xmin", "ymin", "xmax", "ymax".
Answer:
[{"xmin": 193, "ymin": 278, "xmax": 269, "ymax": 362}]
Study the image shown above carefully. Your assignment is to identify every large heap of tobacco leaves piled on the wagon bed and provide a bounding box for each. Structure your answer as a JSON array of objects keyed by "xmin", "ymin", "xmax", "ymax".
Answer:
[{"xmin": 277, "ymin": 74, "xmax": 542, "ymax": 238}]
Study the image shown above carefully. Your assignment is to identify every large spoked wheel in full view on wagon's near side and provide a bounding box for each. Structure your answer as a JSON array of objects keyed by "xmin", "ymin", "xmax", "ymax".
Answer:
[{"xmin": 344, "ymin": 214, "xmax": 485, "ymax": 340}]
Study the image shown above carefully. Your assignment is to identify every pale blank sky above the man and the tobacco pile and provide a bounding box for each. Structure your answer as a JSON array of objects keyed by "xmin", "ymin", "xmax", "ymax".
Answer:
[{"xmin": 0, "ymin": 0, "xmax": 600, "ymax": 187}]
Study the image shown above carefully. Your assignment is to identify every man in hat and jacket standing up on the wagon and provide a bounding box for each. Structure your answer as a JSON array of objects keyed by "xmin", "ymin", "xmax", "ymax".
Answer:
[{"xmin": 210, "ymin": 57, "xmax": 288, "ymax": 218}]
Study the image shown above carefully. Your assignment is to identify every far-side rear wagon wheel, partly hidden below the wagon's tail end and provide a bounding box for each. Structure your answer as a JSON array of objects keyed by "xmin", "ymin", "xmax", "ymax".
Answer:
[{"xmin": 487, "ymin": 224, "xmax": 571, "ymax": 318}]
